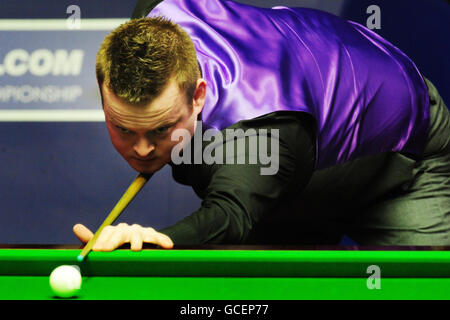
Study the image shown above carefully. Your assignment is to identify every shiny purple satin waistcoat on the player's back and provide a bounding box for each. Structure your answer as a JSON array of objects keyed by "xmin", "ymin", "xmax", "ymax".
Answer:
[{"xmin": 148, "ymin": 0, "xmax": 429, "ymax": 169}]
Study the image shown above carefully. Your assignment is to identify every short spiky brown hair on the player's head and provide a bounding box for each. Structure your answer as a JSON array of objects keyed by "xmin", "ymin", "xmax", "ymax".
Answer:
[{"xmin": 96, "ymin": 17, "xmax": 200, "ymax": 105}]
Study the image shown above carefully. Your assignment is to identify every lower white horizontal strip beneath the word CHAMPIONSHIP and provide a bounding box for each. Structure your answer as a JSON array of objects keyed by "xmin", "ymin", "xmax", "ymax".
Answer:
[{"xmin": 0, "ymin": 109, "xmax": 105, "ymax": 122}]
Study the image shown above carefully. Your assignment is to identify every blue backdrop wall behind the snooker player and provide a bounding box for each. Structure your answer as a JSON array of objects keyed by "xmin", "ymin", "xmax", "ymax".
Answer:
[{"xmin": 0, "ymin": 0, "xmax": 450, "ymax": 244}]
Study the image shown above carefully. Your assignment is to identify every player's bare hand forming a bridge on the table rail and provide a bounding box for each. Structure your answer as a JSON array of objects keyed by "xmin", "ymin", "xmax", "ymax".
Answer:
[{"xmin": 73, "ymin": 223, "xmax": 173, "ymax": 251}]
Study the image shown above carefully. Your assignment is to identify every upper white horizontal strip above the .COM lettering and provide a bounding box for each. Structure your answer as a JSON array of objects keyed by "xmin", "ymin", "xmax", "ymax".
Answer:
[{"xmin": 0, "ymin": 18, "xmax": 130, "ymax": 31}]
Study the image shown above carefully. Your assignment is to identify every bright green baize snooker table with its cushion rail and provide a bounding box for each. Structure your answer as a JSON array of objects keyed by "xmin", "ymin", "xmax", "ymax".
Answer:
[{"xmin": 0, "ymin": 245, "xmax": 450, "ymax": 300}]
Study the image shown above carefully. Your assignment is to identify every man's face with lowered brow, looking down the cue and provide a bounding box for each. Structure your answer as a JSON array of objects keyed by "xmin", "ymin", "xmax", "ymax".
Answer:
[{"xmin": 102, "ymin": 79, "xmax": 206, "ymax": 173}]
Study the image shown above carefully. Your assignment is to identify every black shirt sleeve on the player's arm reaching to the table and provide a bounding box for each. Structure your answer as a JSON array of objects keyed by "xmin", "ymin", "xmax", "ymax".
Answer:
[{"xmin": 159, "ymin": 112, "xmax": 315, "ymax": 244}]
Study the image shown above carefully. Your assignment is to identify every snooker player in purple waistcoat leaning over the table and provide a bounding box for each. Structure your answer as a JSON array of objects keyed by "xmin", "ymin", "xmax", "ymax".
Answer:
[{"xmin": 74, "ymin": 0, "xmax": 450, "ymax": 251}]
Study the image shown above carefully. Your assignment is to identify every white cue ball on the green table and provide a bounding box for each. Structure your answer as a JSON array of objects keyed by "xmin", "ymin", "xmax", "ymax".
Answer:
[{"xmin": 50, "ymin": 265, "xmax": 81, "ymax": 298}]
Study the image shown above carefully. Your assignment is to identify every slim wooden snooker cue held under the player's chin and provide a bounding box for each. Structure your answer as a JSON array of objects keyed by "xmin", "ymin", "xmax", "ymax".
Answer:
[{"xmin": 77, "ymin": 173, "xmax": 152, "ymax": 262}]
